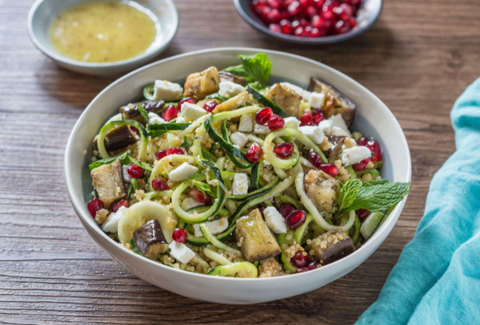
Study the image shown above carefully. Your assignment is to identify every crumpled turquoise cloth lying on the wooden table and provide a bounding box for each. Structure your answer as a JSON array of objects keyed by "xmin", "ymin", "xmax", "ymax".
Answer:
[{"xmin": 356, "ymin": 79, "xmax": 480, "ymax": 325}]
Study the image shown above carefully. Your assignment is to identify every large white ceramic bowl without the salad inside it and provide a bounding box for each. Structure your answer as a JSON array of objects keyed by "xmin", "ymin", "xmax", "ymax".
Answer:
[{"xmin": 65, "ymin": 48, "xmax": 411, "ymax": 304}]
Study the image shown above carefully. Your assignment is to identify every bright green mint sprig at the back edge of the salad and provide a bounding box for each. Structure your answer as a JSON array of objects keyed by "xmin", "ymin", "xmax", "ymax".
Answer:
[{"xmin": 223, "ymin": 53, "xmax": 272, "ymax": 85}]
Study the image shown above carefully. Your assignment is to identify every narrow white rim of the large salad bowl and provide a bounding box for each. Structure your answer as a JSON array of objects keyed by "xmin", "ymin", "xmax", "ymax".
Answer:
[{"xmin": 64, "ymin": 47, "xmax": 412, "ymax": 282}]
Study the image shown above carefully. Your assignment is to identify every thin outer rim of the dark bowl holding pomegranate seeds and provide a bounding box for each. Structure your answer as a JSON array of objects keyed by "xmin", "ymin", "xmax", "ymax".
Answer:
[{"xmin": 233, "ymin": 0, "xmax": 383, "ymax": 44}]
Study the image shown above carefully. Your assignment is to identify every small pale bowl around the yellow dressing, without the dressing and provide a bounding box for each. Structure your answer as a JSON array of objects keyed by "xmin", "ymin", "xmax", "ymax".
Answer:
[{"xmin": 28, "ymin": 0, "xmax": 178, "ymax": 75}]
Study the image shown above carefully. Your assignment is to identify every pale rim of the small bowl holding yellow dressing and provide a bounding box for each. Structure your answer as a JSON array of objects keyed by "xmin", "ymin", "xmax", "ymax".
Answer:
[{"xmin": 27, "ymin": 0, "xmax": 179, "ymax": 69}]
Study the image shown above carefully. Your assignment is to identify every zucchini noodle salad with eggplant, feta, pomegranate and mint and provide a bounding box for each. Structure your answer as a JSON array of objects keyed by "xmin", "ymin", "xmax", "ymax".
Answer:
[{"xmin": 88, "ymin": 53, "xmax": 410, "ymax": 278}]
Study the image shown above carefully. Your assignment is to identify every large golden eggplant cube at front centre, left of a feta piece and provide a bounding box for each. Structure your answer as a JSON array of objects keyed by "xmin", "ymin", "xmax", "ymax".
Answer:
[{"xmin": 235, "ymin": 209, "xmax": 282, "ymax": 262}]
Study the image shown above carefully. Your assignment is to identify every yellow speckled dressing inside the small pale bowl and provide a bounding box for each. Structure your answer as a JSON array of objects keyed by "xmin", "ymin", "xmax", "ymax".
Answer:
[{"xmin": 49, "ymin": 1, "xmax": 159, "ymax": 63}]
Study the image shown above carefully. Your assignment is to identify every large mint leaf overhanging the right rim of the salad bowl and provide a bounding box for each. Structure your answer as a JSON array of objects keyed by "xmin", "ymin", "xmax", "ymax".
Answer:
[{"xmin": 347, "ymin": 180, "xmax": 410, "ymax": 212}]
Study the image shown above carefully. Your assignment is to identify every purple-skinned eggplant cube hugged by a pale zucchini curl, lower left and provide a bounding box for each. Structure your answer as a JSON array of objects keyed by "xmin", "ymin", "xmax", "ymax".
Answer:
[{"xmin": 133, "ymin": 219, "xmax": 167, "ymax": 260}]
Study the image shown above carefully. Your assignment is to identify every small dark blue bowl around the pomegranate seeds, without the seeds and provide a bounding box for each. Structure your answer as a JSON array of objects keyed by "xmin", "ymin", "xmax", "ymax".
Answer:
[{"xmin": 234, "ymin": 0, "xmax": 383, "ymax": 44}]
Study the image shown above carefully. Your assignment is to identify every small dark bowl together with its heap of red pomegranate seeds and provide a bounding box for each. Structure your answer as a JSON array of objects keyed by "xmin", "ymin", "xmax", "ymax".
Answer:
[{"xmin": 234, "ymin": 0, "xmax": 382, "ymax": 44}]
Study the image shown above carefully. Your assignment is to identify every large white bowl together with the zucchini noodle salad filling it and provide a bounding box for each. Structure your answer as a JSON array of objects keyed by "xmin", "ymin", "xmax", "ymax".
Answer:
[{"xmin": 65, "ymin": 48, "xmax": 411, "ymax": 304}]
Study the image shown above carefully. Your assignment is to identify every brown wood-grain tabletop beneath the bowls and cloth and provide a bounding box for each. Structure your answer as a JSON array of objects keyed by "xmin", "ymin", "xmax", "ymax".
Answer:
[{"xmin": 0, "ymin": 0, "xmax": 480, "ymax": 324}]
